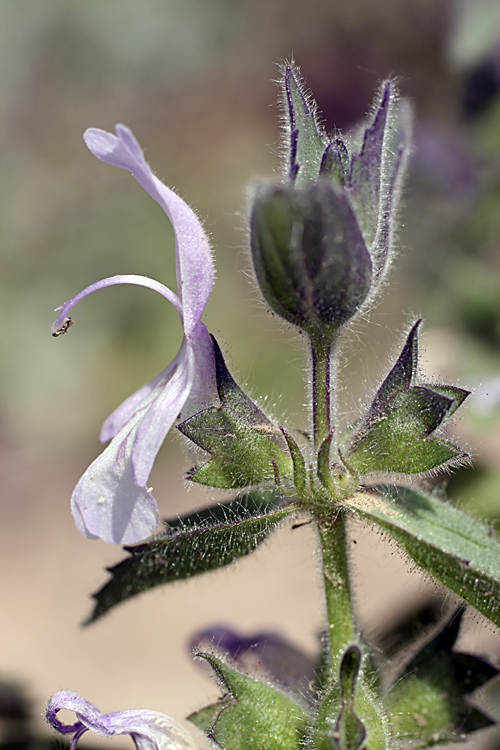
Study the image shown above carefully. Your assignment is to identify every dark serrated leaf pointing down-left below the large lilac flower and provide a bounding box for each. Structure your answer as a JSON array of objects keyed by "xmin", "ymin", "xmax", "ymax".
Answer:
[{"xmin": 88, "ymin": 489, "xmax": 294, "ymax": 623}]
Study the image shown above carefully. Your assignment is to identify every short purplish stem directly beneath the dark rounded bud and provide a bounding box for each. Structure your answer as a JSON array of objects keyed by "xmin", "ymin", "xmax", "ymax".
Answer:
[{"xmin": 311, "ymin": 337, "xmax": 332, "ymax": 452}]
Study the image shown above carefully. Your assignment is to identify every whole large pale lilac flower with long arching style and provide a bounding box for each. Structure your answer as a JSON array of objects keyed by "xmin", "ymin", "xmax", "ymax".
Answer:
[{"xmin": 52, "ymin": 125, "xmax": 217, "ymax": 544}]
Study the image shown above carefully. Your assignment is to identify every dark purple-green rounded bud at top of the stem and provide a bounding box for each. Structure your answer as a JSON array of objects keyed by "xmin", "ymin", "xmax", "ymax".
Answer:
[{"xmin": 251, "ymin": 179, "xmax": 372, "ymax": 335}]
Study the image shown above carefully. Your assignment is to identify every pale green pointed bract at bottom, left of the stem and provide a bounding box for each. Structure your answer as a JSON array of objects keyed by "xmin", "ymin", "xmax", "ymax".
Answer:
[{"xmin": 188, "ymin": 653, "xmax": 308, "ymax": 750}]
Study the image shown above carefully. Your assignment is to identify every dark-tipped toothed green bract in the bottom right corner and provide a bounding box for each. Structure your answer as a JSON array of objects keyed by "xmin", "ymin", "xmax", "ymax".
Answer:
[{"xmin": 387, "ymin": 609, "xmax": 498, "ymax": 747}]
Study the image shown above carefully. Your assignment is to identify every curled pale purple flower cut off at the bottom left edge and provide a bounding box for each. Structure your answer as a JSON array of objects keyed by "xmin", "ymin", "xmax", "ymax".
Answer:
[{"xmin": 45, "ymin": 690, "xmax": 196, "ymax": 750}]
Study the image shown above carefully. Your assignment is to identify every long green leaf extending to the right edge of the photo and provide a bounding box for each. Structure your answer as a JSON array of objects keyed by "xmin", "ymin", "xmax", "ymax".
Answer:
[{"xmin": 344, "ymin": 486, "xmax": 500, "ymax": 627}]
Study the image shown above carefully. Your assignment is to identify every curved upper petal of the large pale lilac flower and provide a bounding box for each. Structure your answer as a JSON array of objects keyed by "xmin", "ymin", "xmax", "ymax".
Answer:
[{"xmin": 83, "ymin": 125, "xmax": 214, "ymax": 338}]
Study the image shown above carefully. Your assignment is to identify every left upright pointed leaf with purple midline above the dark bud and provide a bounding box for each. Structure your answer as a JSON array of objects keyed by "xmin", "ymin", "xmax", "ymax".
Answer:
[{"xmin": 282, "ymin": 65, "xmax": 327, "ymax": 185}]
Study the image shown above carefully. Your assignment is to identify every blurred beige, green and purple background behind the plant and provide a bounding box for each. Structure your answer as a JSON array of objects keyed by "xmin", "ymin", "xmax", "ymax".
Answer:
[{"xmin": 0, "ymin": 0, "xmax": 500, "ymax": 747}]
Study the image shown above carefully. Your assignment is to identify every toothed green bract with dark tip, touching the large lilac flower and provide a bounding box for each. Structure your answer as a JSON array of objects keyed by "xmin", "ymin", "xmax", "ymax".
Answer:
[{"xmin": 177, "ymin": 337, "xmax": 292, "ymax": 489}]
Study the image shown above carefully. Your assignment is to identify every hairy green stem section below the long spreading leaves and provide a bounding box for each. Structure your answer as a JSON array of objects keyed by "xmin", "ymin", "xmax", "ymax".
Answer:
[{"xmin": 319, "ymin": 509, "xmax": 356, "ymax": 675}]
